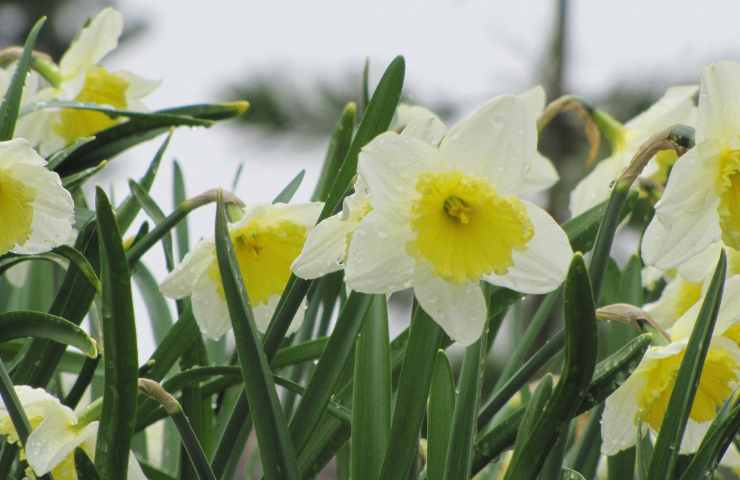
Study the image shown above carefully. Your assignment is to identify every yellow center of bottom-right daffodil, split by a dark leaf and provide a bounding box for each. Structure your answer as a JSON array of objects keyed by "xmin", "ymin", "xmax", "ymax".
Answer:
[{"xmin": 638, "ymin": 348, "xmax": 737, "ymax": 431}]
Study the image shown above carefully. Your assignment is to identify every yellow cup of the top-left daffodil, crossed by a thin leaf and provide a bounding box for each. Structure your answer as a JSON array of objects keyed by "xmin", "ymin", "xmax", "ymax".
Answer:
[{"xmin": 54, "ymin": 67, "xmax": 128, "ymax": 144}]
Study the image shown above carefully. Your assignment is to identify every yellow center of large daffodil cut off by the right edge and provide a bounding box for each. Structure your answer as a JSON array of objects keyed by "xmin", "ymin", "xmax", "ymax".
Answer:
[{"xmin": 717, "ymin": 150, "xmax": 740, "ymax": 249}]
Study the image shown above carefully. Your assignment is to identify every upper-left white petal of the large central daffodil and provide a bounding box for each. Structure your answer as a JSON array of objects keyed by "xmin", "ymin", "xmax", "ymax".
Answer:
[{"xmin": 357, "ymin": 132, "xmax": 439, "ymax": 208}]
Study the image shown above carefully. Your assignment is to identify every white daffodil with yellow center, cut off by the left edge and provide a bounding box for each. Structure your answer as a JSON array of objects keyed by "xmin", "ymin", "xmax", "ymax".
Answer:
[{"xmin": 0, "ymin": 139, "xmax": 74, "ymax": 255}]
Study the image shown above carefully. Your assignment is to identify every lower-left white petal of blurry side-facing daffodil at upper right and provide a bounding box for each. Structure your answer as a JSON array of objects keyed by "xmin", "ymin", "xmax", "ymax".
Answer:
[{"xmin": 570, "ymin": 153, "xmax": 629, "ymax": 217}]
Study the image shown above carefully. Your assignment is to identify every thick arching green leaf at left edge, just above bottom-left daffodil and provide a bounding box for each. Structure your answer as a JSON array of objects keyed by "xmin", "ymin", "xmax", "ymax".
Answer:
[{"xmin": 0, "ymin": 311, "xmax": 98, "ymax": 357}]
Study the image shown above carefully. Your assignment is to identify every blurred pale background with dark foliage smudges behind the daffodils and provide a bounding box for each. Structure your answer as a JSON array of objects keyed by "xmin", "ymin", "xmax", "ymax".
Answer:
[{"xmin": 0, "ymin": 0, "xmax": 740, "ymax": 476}]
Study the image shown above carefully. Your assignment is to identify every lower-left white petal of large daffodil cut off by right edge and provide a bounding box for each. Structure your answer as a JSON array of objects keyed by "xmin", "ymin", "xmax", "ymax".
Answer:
[{"xmin": 642, "ymin": 144, "xmax": 721, "ymax": 270}]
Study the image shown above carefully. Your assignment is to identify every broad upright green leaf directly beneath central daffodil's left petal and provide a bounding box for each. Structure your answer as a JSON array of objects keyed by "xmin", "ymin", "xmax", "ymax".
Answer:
[{"xmin": 350, "ymin": 295, "xmax": 391, "ymax": 480}]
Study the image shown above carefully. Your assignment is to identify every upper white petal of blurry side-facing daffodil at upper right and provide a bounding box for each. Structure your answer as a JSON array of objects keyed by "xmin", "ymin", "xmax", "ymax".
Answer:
[{"xmin": 625, "ymin": 85, "xmax": 698, "ymax": 142}]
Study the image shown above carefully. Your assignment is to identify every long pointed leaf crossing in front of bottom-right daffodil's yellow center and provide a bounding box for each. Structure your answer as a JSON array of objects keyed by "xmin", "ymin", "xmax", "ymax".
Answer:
[{"xmin": 648, "ymin": 250, "xmax": 727, "ymax": 478}]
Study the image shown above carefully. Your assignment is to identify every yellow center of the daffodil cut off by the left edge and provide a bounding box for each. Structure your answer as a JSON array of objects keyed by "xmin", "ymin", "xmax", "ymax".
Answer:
[{"xmin": 0, "ymin": 170, "xmax": 36, "ymax": 255}]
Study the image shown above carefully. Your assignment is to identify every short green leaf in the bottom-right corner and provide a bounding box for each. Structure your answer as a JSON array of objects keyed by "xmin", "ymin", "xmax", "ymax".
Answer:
[{"xmin": 681, "ymin": 400, "xmax": 740, "ymax": 480}]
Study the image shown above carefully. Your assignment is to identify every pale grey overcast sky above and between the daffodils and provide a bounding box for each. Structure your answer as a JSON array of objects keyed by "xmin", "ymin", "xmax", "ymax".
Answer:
[{"xmin": 71, "ymin": 0, "xmax": 740, "ymax": 358}]
